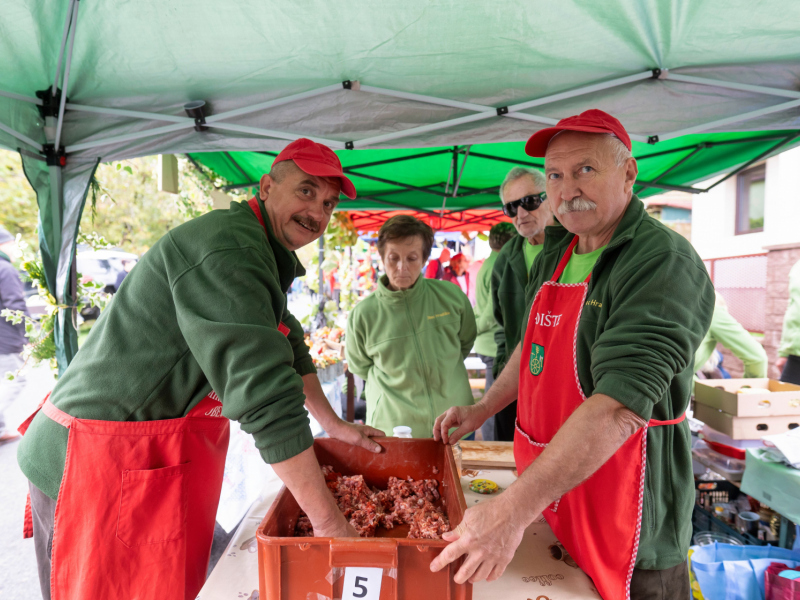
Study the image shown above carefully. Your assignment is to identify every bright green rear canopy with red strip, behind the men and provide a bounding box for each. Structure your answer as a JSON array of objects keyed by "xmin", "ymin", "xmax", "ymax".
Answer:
[{"xmin": 189, "ymin": 130, "xmax": 800, "ymax": 231}]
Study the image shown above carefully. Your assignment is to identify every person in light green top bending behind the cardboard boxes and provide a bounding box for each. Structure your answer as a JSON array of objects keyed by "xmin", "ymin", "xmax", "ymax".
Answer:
[{"xmin": 694, "ymin": 292, "xmax": 767, "ymax": 378}]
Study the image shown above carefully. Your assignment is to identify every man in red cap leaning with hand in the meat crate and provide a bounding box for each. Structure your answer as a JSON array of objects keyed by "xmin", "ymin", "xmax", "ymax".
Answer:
[{"xmin": 18, "ymin": 139, "xmax": 381, "ymax": 600}]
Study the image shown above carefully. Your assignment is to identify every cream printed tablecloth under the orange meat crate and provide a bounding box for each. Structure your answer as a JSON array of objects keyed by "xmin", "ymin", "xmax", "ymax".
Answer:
[{"xmin": 197, "ymin": 469, "xmax": 600, "ymax": 600}]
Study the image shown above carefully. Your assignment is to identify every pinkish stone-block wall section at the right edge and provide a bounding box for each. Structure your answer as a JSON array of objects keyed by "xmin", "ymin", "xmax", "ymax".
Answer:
[{"xmin": 760, "ymin": 244, "xmax": 800, "ymax": 379}]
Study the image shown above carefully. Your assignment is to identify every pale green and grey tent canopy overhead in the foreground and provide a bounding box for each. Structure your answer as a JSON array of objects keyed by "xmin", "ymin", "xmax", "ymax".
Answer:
[{"xmin": 0, "ymin": 0, "xmax": 800, "ymax": 369}]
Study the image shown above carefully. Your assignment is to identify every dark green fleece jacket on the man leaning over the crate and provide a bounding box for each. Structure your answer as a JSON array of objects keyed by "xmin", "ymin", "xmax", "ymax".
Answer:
[{"xmin": 17, "ymin": 202, "xmax": 315, "ymax": 498}]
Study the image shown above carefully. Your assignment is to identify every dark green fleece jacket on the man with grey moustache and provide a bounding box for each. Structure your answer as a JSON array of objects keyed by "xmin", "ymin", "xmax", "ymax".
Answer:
[{"xmin": 519, "ymin": 196, "xmax": 714, "ymax": 569}]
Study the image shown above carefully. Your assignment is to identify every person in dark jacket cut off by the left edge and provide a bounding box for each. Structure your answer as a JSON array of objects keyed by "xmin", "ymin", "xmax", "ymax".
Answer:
[{"xmin": 0, "ymin": 227, "xmax": 28, "ymax": 444}]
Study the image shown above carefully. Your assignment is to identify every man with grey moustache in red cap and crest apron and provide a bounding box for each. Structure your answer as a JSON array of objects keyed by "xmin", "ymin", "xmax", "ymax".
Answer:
[{"xmin": 432, "ymin": 110, "xmax": 714, "ymax": 600}]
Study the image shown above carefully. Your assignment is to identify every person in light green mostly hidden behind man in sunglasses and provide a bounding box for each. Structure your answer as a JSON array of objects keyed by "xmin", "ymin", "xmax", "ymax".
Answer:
[{"xmin": 475, "ymin": 223, "xmax": 517, "ymax": 442}]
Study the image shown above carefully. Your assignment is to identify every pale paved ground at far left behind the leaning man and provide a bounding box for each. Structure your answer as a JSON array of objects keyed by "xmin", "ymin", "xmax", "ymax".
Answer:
[{"xmin": 0, "ymin": 367, "xmax": 55, "ymax": 600}]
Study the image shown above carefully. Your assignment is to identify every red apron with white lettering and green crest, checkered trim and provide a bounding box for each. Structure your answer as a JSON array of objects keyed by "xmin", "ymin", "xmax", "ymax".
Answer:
[{"xmin": 514, "ymin": 236, "xmax": 686, "ymax": 600}]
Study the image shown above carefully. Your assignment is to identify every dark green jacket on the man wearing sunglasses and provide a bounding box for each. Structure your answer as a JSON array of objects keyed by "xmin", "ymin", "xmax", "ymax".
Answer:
[{"xmin": 492, "ymin": 235, "xmax": 528, "ymax": 377}]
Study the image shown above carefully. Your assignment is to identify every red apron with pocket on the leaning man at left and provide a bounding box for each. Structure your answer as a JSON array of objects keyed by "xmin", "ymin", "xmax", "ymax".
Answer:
[{"xmin": 20, "ymin": 198, "xmax": 288, "ymax": 600}]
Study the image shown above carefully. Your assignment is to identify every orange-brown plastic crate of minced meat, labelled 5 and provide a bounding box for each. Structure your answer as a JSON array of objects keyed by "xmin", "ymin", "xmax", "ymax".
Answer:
[{"xmin": 257, "ymin": 438, "xmax": 472, "ymax": 600}]
